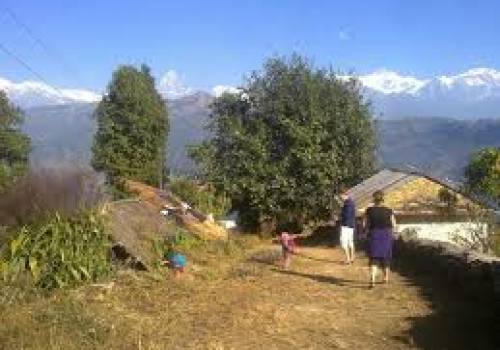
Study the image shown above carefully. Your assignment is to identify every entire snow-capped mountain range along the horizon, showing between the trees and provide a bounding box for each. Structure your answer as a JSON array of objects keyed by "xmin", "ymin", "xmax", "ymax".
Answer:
[{"xmin": 0, "ymin": 68, "xmax": 500, "ymax": 118}]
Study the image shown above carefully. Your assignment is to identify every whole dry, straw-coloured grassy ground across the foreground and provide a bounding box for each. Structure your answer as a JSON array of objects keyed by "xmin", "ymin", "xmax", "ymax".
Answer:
[{"xmin": 0, "ymin": 246, "xmax": 493, "ymax": 349}]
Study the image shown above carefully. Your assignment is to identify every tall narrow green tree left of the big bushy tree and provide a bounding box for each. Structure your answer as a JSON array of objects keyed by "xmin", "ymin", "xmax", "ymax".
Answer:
[{"xmin": 92, "ymin": 65, "xmax": 169, "ymax": 185}]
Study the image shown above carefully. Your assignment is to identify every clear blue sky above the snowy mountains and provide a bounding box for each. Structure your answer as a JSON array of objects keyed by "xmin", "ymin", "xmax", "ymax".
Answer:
[{"xmin": 0, "ymin": 0, "xmax": 500, "ymax": 91}]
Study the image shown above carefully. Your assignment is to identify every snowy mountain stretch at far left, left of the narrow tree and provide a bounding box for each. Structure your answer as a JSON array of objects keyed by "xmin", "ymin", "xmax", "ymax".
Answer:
[{"xmin": 0, "ymin": 78, "xmax": 101, "ymax": 108}]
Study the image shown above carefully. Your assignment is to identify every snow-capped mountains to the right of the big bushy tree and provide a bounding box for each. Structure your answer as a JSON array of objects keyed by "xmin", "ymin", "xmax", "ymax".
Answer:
[{"xmin": 359, "ymin": 68, "xmax": 500, "ymax": 118}]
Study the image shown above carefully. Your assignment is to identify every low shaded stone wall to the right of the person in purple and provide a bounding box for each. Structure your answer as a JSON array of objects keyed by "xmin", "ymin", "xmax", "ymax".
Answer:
[{"xmin": 394, "ymin": 237, "xmax": 500, "ymax": 312}]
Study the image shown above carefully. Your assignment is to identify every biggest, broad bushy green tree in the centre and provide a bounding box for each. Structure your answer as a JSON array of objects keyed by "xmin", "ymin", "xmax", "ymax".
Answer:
[{"xmin": 191, "ymin": 55, "xmax": 375, "ymax": 229}]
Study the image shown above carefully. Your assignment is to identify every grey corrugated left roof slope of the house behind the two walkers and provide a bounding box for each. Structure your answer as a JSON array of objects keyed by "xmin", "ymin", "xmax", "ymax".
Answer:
[{"xmin": 348, "ymin": 169, "xmax": 418, "ymax": 207}]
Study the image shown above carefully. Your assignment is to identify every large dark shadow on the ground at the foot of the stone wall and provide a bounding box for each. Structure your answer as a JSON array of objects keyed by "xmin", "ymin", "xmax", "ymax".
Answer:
[{"xmin": 393, "ymin": 259, "xmax": 500, "ymax": 350}]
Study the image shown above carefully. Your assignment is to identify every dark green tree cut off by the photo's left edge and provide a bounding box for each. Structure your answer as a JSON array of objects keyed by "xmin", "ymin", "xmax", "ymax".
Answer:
[{"xmin": 0, "ymin": 90, "xmax": 30, "ymax": 192}]
